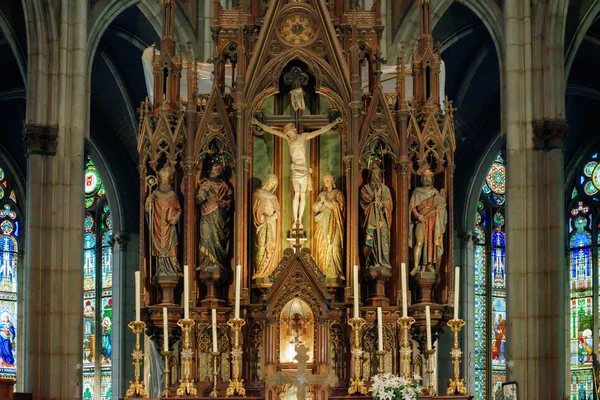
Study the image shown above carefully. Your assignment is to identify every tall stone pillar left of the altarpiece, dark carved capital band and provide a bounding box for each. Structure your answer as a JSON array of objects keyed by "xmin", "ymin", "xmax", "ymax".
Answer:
[{"xmin": 22, "ymin": 0, "xmax": 89, "ymax": 400}]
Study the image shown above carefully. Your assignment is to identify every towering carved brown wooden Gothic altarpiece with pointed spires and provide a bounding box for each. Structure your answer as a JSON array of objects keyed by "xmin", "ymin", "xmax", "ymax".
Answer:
[{"xmin": 138, "ymin": 0, "xmax": 454, "ymax": 400}]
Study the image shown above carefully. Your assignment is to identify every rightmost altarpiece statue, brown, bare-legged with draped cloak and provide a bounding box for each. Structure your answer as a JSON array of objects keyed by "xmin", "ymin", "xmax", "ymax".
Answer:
[{"xmin": 408, "ymin": 169, "xmax": 448, "ymax": 275}]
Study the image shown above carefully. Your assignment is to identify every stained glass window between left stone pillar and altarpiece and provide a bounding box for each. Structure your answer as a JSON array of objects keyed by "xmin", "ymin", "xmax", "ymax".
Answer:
[{"xmin": 82, "ymin": 158, "xmax": 113, "ymax": 400}]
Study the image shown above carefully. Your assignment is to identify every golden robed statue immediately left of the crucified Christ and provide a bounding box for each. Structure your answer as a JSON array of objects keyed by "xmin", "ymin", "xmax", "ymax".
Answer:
[{"xmin": 252, "ymin": 174, "xmax": 281, "ymax": 279}]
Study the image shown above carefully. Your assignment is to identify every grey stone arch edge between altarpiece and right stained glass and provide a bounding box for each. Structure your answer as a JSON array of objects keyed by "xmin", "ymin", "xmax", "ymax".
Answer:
[{"xmin": 454, "ymin": 133, "xmax": 504, "ymax": 393}]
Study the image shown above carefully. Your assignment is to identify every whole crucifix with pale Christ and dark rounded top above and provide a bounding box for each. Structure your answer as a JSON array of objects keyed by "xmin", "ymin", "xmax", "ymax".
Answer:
[{"xmin": 252, "ymin": 67, "xmax": 343, "ymax": 232}]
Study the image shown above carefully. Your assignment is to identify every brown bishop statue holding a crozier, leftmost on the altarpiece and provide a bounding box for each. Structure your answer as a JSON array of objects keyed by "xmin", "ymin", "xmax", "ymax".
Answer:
[{"xmin": 145, "ymin": 165, "xmax": 181, "ymax": 277}]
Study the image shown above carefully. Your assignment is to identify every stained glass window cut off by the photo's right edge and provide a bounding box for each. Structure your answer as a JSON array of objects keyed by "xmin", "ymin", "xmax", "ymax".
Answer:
[{"xmin": 566, "ymin": 153, "xmax": 600, "ymax": 400}]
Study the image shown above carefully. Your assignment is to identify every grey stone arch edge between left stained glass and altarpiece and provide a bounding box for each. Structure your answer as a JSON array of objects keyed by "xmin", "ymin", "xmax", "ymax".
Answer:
[{"xmin": 86, "ymin": 141, "xmax": 138, "ymax": 395}]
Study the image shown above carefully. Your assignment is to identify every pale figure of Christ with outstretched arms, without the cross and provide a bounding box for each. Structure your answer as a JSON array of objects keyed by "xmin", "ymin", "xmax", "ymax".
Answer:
[{"xmin": 252, "ymin": 118, "xmax": 342, "ymax": 230}]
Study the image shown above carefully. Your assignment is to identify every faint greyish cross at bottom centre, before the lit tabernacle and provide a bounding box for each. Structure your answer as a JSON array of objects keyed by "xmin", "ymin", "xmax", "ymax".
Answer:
[{"xmin": 267, "ymin": 344, "xmax": 338, "ymax": 400}]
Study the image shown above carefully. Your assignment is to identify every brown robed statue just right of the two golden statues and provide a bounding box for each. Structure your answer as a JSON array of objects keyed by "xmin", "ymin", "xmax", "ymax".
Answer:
[{"xmin": 360, "ymin": 165, "xmax": 394, "ymax": 268}]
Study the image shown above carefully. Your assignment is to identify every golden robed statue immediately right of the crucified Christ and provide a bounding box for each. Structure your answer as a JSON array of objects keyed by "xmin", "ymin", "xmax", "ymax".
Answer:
[{"xmin": 313, "ymin": 174, "xmax": 345, "ymax": 279}]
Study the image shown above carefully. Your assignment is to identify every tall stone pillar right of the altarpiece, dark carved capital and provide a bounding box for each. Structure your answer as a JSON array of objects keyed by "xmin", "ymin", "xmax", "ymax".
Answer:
[{"xmin": 504, "ymin": 0, "xmax": 567, "ymax": 400}]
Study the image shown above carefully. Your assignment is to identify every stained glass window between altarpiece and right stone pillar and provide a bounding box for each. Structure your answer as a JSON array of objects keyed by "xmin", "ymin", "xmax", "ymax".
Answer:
[{"xmin": 474, "ymin": 153, "xmax": 507, "ymax": 400}]
